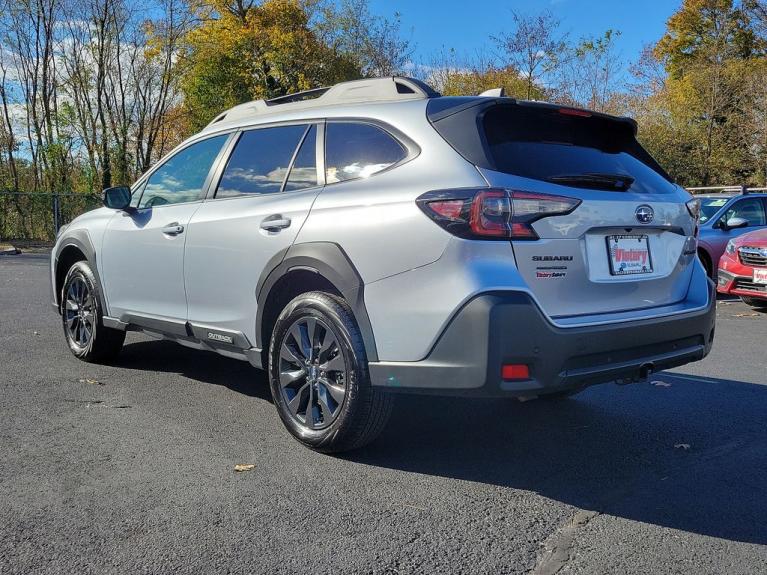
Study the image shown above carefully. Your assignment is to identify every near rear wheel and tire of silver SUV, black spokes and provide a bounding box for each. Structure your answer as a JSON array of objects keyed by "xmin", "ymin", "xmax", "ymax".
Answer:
[{"xmin": 269, "ymin": 292, "xmax": 393, "ymax": 453}]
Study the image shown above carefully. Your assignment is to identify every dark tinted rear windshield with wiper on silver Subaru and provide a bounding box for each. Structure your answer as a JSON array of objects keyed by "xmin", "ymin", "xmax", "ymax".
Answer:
[{"xmin": 483, "ymin": 106, "xmax": 674, "ymax": 194}]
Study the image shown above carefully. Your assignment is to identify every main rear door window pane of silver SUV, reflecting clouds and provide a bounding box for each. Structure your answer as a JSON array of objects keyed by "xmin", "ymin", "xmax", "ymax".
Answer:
[{"xmin": 216, "ymin": 125, "xmax": 306, "ymax": 198}]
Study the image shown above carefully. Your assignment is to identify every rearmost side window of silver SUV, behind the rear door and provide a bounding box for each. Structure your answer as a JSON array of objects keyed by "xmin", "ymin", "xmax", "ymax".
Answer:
[{"xmin": 325, "ymin": 122, "xmax": 407, "ymax": 184}]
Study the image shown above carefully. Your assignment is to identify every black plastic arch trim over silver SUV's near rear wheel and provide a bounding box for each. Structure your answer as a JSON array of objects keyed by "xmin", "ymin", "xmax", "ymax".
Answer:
[{"xmin": 256, "ymin": 242, "xmax": 378, "ymax": 361}]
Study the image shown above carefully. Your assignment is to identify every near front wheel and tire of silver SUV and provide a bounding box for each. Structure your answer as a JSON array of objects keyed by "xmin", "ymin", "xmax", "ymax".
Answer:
[{"xmin": 60, "ymin": 261, "xmax": 125, "ymax": 363}]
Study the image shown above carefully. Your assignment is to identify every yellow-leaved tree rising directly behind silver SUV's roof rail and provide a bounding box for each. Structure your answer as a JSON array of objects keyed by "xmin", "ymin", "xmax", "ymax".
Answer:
[{"xmin": 182, "ymin": 0, "xmax": 362, "ymax": 130}]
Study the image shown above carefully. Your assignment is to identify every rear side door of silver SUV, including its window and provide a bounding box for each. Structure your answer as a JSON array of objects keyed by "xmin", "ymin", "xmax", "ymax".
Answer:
[{"xmin": 184, "ymin": 123, "xmax": 323, "ymax": 347}]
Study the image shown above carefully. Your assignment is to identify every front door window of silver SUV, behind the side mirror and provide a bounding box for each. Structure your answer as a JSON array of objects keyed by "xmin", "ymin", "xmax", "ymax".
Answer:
[{"xmin": 139, "ymin": 134, "xmax": 229, "ymax": 208}]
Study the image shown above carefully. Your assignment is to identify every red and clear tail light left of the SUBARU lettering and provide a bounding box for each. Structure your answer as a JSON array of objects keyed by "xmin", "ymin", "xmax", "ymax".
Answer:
[{"xmin": 416, "ymin": 188, "xmax": 581, "ymax": 240}]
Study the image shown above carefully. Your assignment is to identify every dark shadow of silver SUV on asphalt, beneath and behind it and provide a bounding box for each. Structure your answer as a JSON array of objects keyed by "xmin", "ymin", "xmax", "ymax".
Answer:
[{"xmin": 119, "ymin": 342, "xmax": 767, "ymax": 544}]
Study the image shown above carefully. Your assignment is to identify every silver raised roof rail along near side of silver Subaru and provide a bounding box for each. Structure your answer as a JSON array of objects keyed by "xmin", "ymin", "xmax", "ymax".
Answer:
[{"xmin": 207, "ymin": 76, "xmax": 439, "ymax": 128}]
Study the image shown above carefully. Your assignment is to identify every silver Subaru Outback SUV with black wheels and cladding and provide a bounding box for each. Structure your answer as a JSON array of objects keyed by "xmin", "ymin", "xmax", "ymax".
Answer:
[{"xmin": 51, "ymin": 77, "xmax": 715, "ymax": 452}]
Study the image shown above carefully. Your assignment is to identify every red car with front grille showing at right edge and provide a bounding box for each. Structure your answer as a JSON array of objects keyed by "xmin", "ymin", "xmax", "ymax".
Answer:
[{"xmin": 716, "ymin": 230, "xmax": 767, "ymax": 308}]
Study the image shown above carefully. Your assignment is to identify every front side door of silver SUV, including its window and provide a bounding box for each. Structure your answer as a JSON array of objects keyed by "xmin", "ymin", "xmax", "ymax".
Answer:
[{"xmin": 101, "ymin": 134, "xmax": 230, "ymax": 331}]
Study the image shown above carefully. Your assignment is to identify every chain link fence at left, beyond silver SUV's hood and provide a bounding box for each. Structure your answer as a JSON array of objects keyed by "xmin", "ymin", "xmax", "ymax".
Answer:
[{"xmin": 0, "ymin": 190, "xmax": 101, "ymax": 242}]
